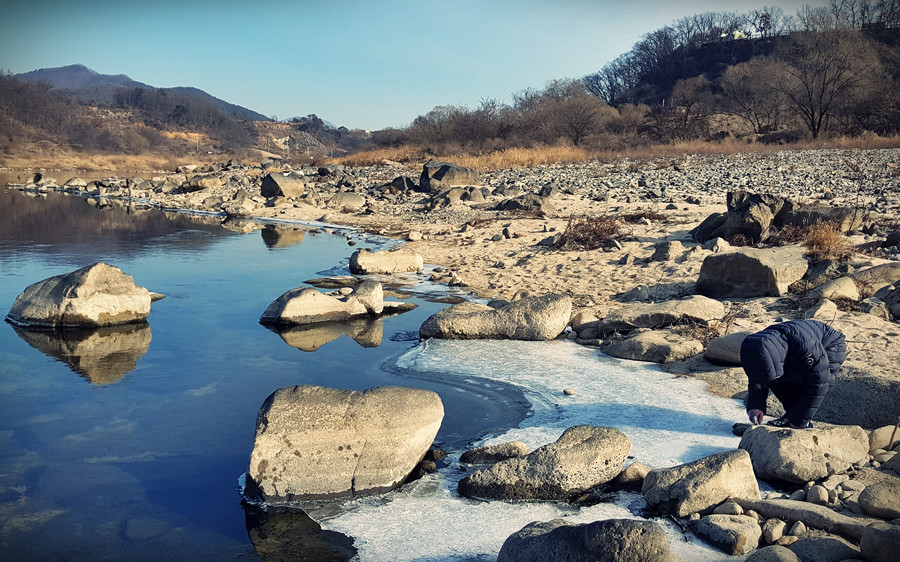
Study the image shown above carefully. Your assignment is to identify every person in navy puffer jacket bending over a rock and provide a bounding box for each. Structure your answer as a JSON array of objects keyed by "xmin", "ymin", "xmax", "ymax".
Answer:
[{"xmin": 741, "ymin": 320, "xmax": 847, "ymax": 427}]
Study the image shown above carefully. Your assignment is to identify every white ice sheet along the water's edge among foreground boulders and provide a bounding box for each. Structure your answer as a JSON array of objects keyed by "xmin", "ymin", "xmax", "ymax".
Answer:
[{"xmin": 321, "ymin": 340, "xmax": 744, "ymax": 561}]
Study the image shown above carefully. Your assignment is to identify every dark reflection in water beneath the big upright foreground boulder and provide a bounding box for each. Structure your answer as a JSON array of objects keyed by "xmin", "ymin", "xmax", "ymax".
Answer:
[{"xmin": 244, "ymin": 504, "xmax": 356, "ymax": 562}]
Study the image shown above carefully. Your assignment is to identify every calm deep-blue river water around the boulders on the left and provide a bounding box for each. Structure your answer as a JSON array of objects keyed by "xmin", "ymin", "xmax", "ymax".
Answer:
[{"xmin": 0, "ymin": 189, "xmax": 526, "ymax": 560}]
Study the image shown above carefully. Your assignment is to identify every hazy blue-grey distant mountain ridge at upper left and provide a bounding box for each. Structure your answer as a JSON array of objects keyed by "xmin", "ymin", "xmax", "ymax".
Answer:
[{"xmin": 16, "ymin": 64, "xmax": 270, "ymax": 121}]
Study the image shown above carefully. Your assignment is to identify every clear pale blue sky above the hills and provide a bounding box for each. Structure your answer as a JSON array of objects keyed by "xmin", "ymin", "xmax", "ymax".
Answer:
[{"xmin": 0, "ymin": 0, "xmax": 824, "ymax": 130}]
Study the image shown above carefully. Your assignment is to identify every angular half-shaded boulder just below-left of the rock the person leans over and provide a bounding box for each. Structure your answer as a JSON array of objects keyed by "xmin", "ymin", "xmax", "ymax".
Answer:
[{"xmin": 641, "ymin": 449, "xmax": 760, "ymax": 517}]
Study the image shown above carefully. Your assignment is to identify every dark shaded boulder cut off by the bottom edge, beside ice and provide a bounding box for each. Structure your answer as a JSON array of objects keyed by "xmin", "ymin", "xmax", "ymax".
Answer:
[{"xmin": 497, "ymin": 519, "xmax": 678, "ymax": 562}]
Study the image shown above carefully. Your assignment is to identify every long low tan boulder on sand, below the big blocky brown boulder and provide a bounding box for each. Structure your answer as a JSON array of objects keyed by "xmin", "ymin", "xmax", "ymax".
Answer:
[{"xmin": 597, "ymin": 295, "xmax": 725, "ymax": 332}]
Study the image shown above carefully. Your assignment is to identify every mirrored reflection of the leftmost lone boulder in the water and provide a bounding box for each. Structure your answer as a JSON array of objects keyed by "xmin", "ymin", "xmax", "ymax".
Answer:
[{"xmin": 13, "ymin": 322, "xmax": 151, "ymax": 384}]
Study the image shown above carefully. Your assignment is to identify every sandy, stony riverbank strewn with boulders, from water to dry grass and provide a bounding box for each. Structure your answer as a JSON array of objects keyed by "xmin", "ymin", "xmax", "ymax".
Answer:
[{"xmin": 7, "ymin": 149, "xmax": 900, "ymax": 560}]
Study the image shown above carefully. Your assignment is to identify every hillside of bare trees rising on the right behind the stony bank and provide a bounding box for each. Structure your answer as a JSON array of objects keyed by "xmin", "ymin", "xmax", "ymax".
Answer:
[{"xmin": 374, "ymin": 0, "xmax": 900, "ymax": 151}]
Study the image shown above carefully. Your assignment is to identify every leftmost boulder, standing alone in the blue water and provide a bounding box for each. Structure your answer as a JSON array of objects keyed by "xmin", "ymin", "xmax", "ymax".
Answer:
[{"xmin": 6, "ymin": 262, "xmax": 151, "ymax": 328}]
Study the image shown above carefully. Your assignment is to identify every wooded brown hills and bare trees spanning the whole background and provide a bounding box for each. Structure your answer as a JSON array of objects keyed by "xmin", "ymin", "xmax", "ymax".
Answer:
[{"xmin": 0, "ymin": 0, "xmax": 900, "ymax": 170}]
